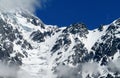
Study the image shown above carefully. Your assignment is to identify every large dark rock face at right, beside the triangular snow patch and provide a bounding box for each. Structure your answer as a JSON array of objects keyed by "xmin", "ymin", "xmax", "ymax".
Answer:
[{"xmin": 92, "ymin": 25, "xmax": 120, "ymax": 64}]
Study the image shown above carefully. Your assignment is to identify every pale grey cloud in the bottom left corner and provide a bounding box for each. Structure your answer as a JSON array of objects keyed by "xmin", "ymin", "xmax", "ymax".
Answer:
[{"xmin": 0, "ymin": 62, "xmax": 33, "ymax": 78}]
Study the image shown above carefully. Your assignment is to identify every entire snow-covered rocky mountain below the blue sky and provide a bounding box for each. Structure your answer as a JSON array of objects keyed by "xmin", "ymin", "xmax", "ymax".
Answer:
[{"xmin": 0, "ymin": 11, "xmax": 120, "ymax": 78}]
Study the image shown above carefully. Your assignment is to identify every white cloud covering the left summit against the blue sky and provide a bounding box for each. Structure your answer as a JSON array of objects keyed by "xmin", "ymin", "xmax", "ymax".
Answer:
[{"xmin": 0, "ymin": 0, "xmax": 47, "ymax": 12}]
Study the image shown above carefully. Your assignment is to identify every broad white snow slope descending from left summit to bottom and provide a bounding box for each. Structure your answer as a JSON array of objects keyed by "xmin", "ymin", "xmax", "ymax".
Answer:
[{"xmin": 0, "ymin": 12, "xmax": 60, "ymax": 78}]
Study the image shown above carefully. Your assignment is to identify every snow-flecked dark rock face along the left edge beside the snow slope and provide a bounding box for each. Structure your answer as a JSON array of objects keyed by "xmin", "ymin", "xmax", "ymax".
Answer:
[{"xmin": 0, "ymin": 15, "xmax": 32, "ymax": 78}]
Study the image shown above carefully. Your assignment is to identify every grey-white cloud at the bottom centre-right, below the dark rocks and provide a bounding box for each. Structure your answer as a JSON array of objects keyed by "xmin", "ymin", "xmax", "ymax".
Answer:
[{"xmin": 55, "ymin": 62, "xmax": 100, "ymax": 78}]
